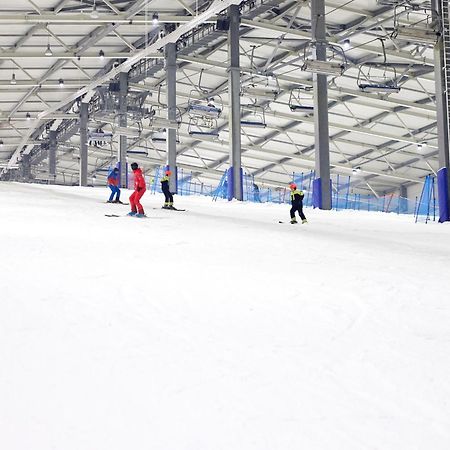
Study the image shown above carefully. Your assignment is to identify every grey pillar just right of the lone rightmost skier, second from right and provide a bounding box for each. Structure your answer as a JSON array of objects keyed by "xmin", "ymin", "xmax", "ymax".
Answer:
[{"xmin": 311, "ymin": 0, "xmax": 331, "ymax": 209}]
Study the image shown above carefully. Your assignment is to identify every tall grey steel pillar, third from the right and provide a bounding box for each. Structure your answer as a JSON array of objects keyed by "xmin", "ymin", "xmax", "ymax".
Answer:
[{"xmin": 228, "ymin": 5, "xmax": 243, "ymax": 200}]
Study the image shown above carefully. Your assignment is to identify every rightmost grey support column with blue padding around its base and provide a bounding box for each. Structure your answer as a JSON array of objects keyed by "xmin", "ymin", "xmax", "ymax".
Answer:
[{"xmin": 431, "ymin": 0, "xmax": 450, "ymax": 222}]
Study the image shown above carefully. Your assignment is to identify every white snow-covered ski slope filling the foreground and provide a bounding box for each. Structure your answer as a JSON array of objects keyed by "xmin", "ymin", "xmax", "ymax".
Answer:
[{"xmin": 0, "ymin": 183, "xmax": 450, "ymax": 450}]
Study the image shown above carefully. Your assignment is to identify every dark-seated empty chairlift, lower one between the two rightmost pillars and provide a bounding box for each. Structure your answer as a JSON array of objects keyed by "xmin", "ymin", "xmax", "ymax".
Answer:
[{"xmin": 357, "ymin": 39, "xmax": 400, "ymax": 94}]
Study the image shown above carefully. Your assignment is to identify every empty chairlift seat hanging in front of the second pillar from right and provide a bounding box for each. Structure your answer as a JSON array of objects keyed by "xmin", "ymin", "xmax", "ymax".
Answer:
[{"xmin": 301, "ymin": 42, "xmax": 348, "ymax": 77}]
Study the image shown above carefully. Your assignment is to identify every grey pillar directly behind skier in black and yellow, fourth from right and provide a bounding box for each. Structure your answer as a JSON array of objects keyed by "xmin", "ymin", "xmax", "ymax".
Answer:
[{"xmin": 165, "ymin": 43, "xmax": 177, "ymax": 193}]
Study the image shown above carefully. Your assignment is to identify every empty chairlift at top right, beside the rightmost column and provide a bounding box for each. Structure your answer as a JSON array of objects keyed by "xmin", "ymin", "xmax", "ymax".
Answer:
[{"xmin": 391, "ymin": 3, "xmax": 441, "ymax": 45}]
